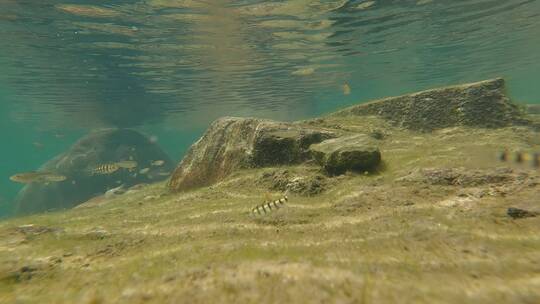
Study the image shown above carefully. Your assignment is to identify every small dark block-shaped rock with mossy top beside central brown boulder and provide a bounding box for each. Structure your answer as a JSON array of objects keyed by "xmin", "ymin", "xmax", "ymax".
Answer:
[{"xmin": 310, "ymin": 134, "xmax": 381, "ymax": 175}]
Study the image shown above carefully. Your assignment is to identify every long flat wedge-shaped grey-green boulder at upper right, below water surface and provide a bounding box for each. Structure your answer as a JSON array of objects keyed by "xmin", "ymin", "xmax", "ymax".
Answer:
[{"xmin": 334, "ymin": 78, "xmax": 529, "ymax": 131}]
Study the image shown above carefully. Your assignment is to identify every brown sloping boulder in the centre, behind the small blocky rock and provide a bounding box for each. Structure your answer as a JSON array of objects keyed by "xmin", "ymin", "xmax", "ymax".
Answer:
[{"xmin": 169, "ymin": 117, "xmax": 334, "ymax": 191}]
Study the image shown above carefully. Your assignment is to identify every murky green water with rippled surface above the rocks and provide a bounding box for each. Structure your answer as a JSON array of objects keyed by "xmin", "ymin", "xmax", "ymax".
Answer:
[{"xmin": 0, "ymin": 0, "xmax": 540, "ymax": 218}]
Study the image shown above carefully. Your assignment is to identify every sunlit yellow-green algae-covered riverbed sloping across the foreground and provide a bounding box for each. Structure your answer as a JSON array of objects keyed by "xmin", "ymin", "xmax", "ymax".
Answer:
[{"xmin": 0, "ymin": 79, "xmax": 540, "ymax": 303}]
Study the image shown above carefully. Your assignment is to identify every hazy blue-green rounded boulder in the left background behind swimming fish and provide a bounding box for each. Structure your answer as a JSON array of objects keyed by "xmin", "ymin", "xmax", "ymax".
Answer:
[{"xmin": 16, "ymin": 129, "xmax": 174, "ymax": 214}]
